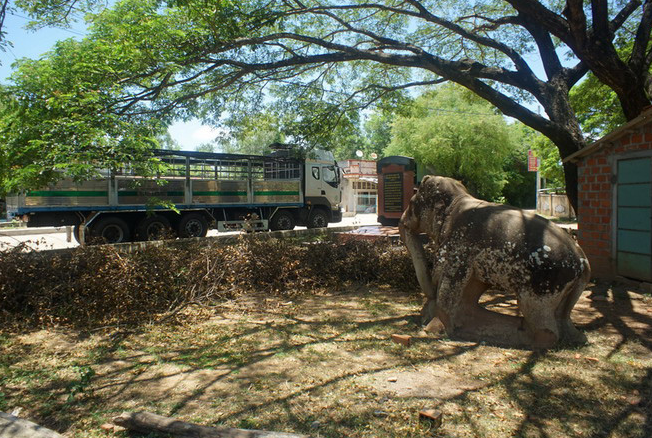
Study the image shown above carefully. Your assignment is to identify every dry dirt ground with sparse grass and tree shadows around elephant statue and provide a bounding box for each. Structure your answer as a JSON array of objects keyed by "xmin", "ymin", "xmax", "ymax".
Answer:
[{"xmin": 0, "ymin": 283, "xmax": 652, "ymax": 437}]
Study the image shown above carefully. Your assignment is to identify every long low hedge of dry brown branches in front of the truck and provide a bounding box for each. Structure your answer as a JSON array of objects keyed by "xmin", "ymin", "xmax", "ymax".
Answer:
[{"xmin": 0, "ymin": 239, "xmax": 417, "ymax": 326}]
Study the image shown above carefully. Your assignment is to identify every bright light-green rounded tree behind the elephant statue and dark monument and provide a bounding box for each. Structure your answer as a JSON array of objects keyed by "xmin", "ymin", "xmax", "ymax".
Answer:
[{"xmin": 385, "ymin": 85, "xmax": 517, "ymax": 200}]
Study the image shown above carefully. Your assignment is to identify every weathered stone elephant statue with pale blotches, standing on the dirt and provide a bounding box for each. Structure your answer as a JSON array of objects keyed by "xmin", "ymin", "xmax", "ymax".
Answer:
[{"xmin": 399, "ymin": 176, "xmax": 591, "ymax": 349}]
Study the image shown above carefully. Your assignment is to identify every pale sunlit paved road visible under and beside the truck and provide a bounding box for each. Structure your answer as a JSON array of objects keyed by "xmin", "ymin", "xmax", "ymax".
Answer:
[{"xmin": 0, "ymin": 214, "xmax": 377, "ymax": 250}]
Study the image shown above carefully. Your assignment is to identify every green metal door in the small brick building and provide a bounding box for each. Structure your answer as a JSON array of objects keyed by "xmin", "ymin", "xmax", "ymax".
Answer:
[{"xmin": 616, "ymin": 157, "xmax": 652, "ymax": 280}]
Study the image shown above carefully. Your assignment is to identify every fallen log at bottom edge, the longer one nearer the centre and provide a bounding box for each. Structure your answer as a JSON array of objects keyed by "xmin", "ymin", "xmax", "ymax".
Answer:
[{"xmin": 113, "ymin": 412, "xmax": 309, "ymax": 438}]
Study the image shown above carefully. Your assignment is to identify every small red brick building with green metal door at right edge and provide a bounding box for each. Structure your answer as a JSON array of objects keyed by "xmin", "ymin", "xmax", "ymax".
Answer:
[{"xmin": 564, "ymin": 109, "xmax": 652, "ymax": 281}]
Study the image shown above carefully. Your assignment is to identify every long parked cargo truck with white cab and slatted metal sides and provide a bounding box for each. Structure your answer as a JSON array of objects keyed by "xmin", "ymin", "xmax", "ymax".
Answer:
[{"xmin": 7, "ymin": 150, "xmax": 342, "ymax": 243}]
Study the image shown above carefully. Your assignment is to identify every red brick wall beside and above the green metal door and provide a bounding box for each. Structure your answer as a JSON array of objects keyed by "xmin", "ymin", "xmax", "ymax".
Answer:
[{"xmin": 578, "ymin": 124, "xmax": 652, "ymax": 277}]
